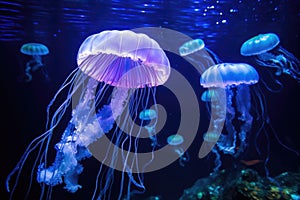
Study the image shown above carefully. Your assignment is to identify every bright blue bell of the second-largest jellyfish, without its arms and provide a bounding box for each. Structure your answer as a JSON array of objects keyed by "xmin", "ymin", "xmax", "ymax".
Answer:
[{"xmin": 200, "ymin": 63, "xmax": 259, "ymax": 88}]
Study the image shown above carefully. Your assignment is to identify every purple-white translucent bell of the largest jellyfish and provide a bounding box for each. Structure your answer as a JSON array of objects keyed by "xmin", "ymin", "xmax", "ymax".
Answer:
[{"xmin": 77, "ymin": 30, "xmax": 170, "ymax": 88}]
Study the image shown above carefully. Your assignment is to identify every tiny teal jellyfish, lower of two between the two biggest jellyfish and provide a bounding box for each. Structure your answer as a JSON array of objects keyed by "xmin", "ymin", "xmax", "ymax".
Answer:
[{"xmin": 167, "ymin": 133, "xmax": 190, "ymax": 167}]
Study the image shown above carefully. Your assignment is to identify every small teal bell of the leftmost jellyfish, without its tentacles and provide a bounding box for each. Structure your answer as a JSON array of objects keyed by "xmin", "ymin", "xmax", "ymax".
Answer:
[{"xmin": 20, "ymin": 43, "xmax": 49, "ymax": 56}]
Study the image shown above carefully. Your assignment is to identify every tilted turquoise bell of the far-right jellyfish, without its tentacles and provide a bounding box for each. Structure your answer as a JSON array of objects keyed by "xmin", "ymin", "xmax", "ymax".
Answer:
[{"xmin": 240, "ymin": 33, "xmax": 280, "ymax": 56}]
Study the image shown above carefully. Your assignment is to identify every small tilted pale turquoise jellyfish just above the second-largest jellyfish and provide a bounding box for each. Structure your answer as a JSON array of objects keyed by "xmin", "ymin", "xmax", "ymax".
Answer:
[{"xmin": 179, "ymin": 39, "xmax": 222, "ymax": 72}]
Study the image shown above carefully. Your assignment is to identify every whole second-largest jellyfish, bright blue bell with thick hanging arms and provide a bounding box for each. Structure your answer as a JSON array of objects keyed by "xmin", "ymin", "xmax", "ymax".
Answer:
[{"xmin": 200, "ymin": 63, "xmax": 259, "ymax": 156}]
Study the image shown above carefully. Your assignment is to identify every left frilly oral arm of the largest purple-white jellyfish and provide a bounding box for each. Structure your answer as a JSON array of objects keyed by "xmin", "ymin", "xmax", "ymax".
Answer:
[{"xmin": 37, "ymin": 79, "xmax": 113, "ymax": 193}]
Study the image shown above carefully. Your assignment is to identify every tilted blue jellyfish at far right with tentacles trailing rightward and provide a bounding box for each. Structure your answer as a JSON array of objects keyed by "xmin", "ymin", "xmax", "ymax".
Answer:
[{"xmin": 240, "ymin": 33, "xmax": 300, "ymax": 82}]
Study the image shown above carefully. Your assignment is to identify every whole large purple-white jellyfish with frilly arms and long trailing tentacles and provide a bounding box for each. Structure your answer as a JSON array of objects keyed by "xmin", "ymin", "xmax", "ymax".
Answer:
[{"xmin": 6, "ymin": 30, "xmax": 170, "ymax": 199}]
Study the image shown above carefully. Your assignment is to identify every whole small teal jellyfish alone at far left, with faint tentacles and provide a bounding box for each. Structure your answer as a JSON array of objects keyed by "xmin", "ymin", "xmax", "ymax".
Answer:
[{"xmin": 20, "ymin": 43, "xmax": 49, "ymax": 82}]
